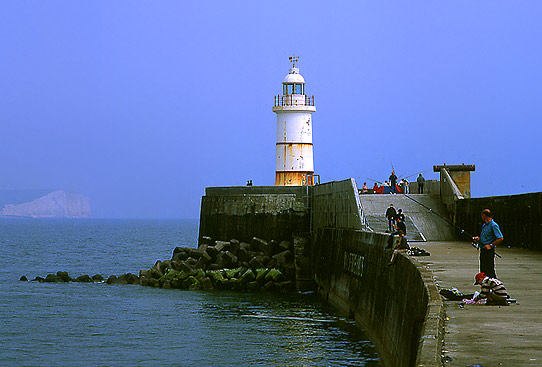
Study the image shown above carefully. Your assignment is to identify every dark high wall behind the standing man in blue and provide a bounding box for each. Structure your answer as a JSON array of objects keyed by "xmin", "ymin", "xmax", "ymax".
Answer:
[{"xmin": 455, "ymin": 192, "xmax": 542, "ymax": 250}]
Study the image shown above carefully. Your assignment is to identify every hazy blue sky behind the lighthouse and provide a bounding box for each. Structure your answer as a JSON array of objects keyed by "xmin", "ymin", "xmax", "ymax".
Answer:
[{"xmin": 0, "ymin": 0, "xmax": 542, "ymax": 218}]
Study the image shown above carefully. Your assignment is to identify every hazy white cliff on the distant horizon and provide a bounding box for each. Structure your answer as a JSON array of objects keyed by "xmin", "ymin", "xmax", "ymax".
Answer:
[{"xmin": 0, "ymin": 190, "xmax": 90, "ymax": 218}]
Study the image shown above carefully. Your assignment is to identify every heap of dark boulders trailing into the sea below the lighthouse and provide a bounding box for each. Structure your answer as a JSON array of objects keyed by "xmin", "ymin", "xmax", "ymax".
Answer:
[{"xmin": 20, "ymin": 236, "xmax": 295, "ymax": 291}]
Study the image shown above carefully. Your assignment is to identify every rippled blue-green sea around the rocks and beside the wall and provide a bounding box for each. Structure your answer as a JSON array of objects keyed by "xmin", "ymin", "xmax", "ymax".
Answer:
[{"xmin": 0, "ymin": 219, "xmax": 380, "ymax": 366}]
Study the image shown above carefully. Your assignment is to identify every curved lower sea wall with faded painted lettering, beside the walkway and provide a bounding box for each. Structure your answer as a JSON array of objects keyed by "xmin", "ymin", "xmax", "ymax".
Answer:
[{"xmin": 313, "ymin": 228, "xmax": 444, "ymax": 367}]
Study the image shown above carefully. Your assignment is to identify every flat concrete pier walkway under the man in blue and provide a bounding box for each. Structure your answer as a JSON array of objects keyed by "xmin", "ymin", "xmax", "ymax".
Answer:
[{"xmin": 411, "ymin": 242, "xmax": 542, "ymax": 367}]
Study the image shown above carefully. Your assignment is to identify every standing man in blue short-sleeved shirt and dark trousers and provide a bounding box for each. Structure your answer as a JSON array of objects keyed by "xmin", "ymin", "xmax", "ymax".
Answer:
[{"xmin": 472, "ymin": 209, "xmax": 504, "ymax": 278}]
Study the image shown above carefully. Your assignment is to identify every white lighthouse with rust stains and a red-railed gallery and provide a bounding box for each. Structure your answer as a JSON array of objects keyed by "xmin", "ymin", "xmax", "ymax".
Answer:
[{"xmin": 273, "ymin": 56, "xmax": 316, "ymax": 186}]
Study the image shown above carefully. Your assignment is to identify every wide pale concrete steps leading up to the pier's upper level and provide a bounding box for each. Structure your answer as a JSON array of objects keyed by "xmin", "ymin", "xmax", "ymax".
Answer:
[{"xmin": 359, "ymin": 194, "xmax": 456, "ymax": 241}]
